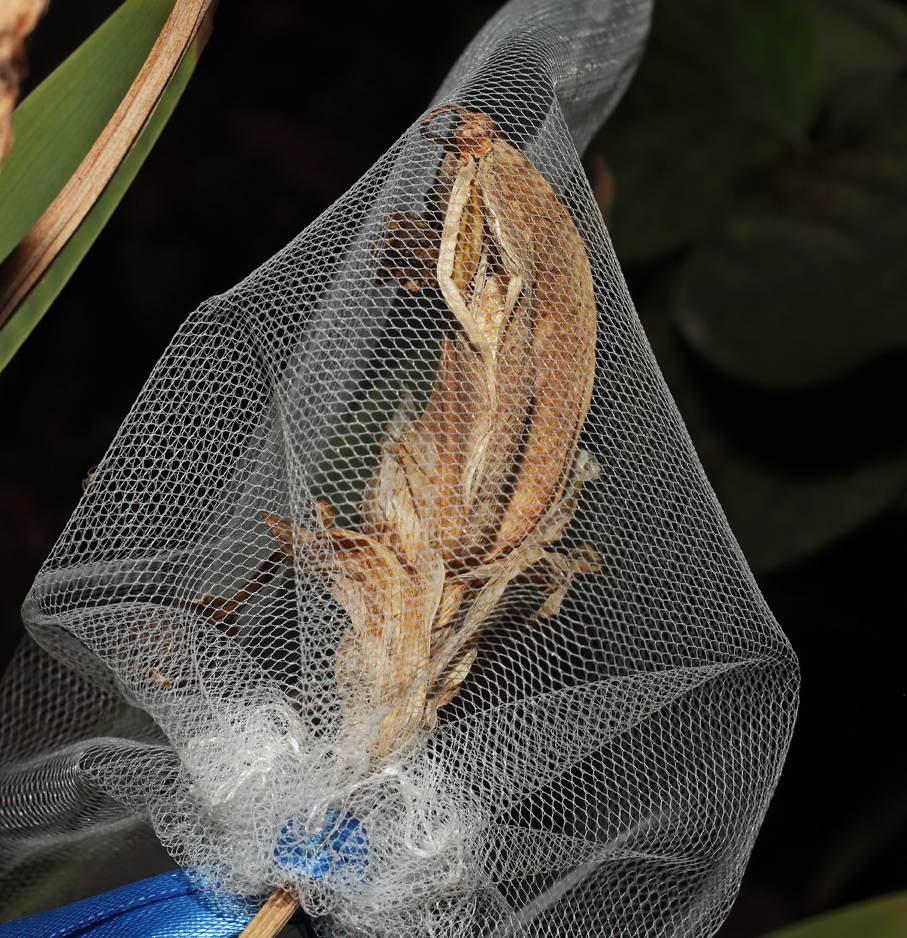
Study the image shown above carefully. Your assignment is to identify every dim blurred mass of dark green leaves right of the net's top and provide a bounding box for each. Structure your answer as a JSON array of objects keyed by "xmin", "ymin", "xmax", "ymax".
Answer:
[{"xmin": 588, "ymin": 0, "xmax": 907, "ymax": 573}]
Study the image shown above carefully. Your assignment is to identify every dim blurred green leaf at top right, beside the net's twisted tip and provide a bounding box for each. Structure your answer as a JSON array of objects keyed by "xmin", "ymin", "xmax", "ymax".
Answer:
[{"xmin": 600, "ymin": 0, "xmax": 822, "ymax": 262}]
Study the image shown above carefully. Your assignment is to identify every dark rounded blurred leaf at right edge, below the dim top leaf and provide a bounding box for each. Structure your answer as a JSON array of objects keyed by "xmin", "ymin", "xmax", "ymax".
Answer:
[{"xmin": 673, "ymin": 80, "xmax": 907, "ymax": 387}]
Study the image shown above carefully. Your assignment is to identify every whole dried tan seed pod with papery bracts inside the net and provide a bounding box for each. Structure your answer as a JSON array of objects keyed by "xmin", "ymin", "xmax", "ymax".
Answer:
[{"xmin": 263, "ymin": 109, "xmax": 598, "ymax": 758}]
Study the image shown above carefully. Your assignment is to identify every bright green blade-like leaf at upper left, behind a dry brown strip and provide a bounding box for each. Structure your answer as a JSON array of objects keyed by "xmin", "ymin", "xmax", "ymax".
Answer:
[{"xmin": 0, "ymin": 0, "xmax": 204, "ymax": 369}]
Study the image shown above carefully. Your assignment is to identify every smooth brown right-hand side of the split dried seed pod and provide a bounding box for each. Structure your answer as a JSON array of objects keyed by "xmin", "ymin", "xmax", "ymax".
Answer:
[{"xmin": 446, "ymin": 112, "xmax": 596, "ymax": 558}]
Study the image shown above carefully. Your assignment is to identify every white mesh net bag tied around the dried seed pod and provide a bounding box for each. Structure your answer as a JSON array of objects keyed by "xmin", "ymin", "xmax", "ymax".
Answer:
[{"xmin": 0, "ymin": 0, "xmax": 797, "ymax": 936}]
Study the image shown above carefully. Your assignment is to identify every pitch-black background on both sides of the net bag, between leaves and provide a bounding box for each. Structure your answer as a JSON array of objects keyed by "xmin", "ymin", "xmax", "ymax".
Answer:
[{"xmin": 0, "ymin": 0, "xmax": 907, "ymax": 938}]
